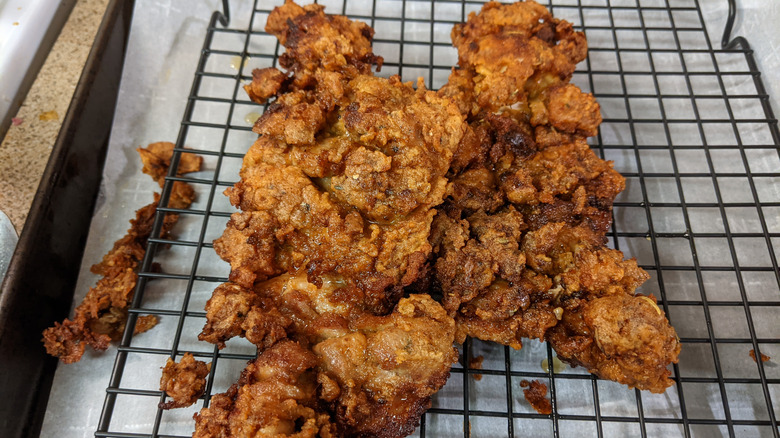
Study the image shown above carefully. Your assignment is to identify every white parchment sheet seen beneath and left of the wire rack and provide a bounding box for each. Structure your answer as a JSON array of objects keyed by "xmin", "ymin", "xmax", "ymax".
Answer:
[{"xmin": 41, "ymin": 0, "xmax": 780, "ymax": 438}]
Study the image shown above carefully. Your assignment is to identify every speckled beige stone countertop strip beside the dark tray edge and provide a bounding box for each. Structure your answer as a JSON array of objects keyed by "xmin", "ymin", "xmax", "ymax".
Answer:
[{"xmin": 0, "ymin": 0, "xmax": 109, "ymax": 232}]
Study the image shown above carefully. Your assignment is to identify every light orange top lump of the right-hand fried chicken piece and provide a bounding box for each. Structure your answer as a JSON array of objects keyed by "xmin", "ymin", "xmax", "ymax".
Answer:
[{"xmin": 442, "ymin": 1, "xmax": 601, "ymax": 126}]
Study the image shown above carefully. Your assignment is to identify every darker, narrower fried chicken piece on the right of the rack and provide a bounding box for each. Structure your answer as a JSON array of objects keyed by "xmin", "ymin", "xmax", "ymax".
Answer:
[{"xmin": 431, "ymin": 1, "xmax": 679, "ymax": 392}]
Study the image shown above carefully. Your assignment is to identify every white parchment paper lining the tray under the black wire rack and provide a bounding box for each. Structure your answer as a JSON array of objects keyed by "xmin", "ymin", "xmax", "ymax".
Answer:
[{"xmin": 41, "ymin": 0, "xmax": 780, "ymax": 438}]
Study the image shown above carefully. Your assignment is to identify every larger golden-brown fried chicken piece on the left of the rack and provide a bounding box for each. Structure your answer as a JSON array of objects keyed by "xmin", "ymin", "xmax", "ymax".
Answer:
[{"xmin": 195, "ymin": 2, "xmax": 465, "ymax": 437}]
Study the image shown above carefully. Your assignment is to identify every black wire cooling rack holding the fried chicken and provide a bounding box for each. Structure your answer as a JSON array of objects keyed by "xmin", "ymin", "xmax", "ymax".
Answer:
[{"xmin": 95, "ymin": 0, "xmax": 780, "ymax": 437}]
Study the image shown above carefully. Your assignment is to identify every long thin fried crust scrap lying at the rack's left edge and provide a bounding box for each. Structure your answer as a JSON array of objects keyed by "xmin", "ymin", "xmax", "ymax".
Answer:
[{"xmin": 43, "ymin": 142, "xmax": 202, "ymax": 363}]
